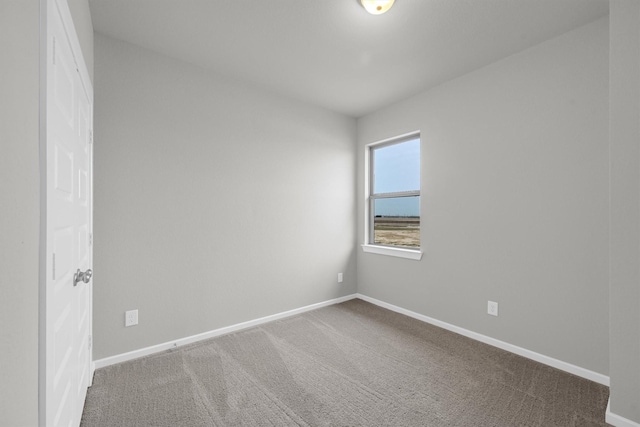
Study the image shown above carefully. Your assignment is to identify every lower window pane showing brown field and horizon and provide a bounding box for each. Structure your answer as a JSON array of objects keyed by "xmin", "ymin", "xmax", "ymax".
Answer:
[{"xmin": 373, "ymin": 196, "xmax": 420, "ymax": 247}]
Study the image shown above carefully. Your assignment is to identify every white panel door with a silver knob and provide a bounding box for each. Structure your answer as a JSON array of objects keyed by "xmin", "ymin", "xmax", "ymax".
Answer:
[{"xmin": 41, "ymin": 0, "xmax": 93, "ymax": 427}]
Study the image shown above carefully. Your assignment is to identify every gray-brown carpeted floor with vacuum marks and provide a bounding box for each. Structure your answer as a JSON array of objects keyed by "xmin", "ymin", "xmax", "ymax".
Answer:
[{"xmin": 82, "ymin": 300, "xmax": 609, "ymax": 427}]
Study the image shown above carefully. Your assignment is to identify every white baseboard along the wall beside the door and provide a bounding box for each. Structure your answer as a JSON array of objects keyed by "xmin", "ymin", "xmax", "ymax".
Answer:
[{"xmin": 94, "ymin": 294, "xmax": 356, "ymax": 369}]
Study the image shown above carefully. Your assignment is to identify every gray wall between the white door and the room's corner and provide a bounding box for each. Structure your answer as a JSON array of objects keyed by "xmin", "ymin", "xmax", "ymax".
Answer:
[{"xmin": 94, "ymin": 34, "xmax": 356, "ymax": 359}]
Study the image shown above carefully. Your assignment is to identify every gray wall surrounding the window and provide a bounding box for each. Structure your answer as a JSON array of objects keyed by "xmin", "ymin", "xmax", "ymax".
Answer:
[{"xmin": 357, "ymin": 18, "xmax": 609, "ymax": 375}]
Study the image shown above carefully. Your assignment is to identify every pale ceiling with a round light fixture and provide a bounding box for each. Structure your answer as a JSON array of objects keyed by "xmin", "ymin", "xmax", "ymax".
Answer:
[{"xmin": 89, "ymin": 0, "xmax": 609, "ymax": 117}]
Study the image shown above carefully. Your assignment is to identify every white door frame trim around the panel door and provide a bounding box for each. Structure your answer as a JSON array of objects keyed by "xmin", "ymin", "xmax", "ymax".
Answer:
[{"xmin": 38, "ymin": 0, "xmax": 95, "ymax": 427}]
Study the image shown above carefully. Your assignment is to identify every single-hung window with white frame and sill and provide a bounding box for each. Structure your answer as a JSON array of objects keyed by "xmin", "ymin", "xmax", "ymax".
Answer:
[{"xmin": 363, "ymin": 133, "xmax": 422, "ymax": 259}]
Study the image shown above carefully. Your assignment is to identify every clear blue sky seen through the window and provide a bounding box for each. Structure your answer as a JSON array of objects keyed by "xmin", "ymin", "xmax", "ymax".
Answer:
[{"xmin": 373, "ymin": 139, "xmax": 420, "ymax": 216}]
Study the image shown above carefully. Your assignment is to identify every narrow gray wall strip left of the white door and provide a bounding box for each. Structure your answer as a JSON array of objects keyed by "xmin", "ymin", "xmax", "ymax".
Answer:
[{"xmin": 0, "ymin": 0, "xmax": 40, "ymax": 426}]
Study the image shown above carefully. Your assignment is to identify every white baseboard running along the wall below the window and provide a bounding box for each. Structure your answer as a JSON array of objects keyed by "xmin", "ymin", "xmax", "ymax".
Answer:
[{"xmin": 356, "ymin": 294, "xmax": 608, "ymax": 388}]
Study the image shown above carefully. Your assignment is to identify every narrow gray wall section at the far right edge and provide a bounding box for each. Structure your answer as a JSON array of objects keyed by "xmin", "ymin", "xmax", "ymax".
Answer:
[{"xmin": 609, "ymin": 0, "xmax": 640, "ymax": 423}]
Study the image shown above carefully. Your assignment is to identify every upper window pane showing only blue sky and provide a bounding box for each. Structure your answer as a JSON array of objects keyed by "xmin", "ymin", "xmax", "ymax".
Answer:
[{"xmin": 373, "ymin": 138, "xmax": 420, "ymax": 194}]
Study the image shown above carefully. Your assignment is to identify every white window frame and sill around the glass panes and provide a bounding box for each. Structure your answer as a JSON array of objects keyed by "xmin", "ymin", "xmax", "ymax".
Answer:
[{"xmin": 362, "ymin": 131, "xmax": 423, "ymax": 261}]
